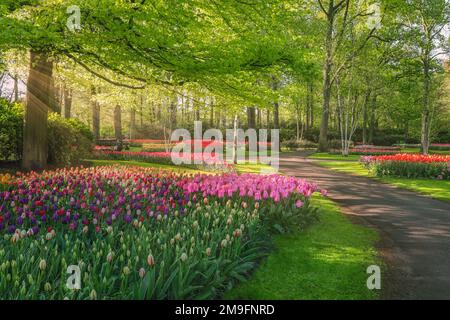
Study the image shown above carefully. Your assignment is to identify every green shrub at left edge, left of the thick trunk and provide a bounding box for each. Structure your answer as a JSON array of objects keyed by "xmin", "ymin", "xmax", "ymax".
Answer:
[{"xmin": 0, "ymin": 98, "xmax": 23, "ymax": 160}]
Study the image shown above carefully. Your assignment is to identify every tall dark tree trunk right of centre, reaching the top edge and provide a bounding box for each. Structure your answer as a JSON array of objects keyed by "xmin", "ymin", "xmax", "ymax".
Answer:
[{"xmin": 319, "ymin": 1, "xmax": 334, "ymax": 152}]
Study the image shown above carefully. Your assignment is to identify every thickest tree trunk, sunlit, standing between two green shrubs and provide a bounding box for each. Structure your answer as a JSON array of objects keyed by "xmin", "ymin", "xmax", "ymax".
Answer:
[{"xmin": 22, "ymin": 51, "xmax": 53, "ymax": 170}]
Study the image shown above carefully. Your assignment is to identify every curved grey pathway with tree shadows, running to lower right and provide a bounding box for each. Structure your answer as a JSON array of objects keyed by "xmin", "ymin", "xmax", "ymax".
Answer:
[{"xmin": 280, "ymin": 152, "xmax": 450, "ymax": 299}]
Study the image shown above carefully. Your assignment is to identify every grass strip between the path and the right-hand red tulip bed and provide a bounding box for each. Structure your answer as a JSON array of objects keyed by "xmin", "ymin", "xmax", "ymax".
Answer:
[{"xmin": 317, "ymin": 161, "xmax": 450, "ymax": 202}]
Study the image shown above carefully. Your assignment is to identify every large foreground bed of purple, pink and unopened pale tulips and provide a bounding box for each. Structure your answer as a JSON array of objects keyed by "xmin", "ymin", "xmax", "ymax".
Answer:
[{"xmin": 0, "ymin": 166, "xmax": 325, "ymax": 299}]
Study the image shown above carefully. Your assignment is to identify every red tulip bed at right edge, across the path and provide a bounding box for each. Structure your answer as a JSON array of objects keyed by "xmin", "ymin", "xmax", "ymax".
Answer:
[{"xmin": 360, "ymin": 154, "xmax": 450, "ymax": 180}]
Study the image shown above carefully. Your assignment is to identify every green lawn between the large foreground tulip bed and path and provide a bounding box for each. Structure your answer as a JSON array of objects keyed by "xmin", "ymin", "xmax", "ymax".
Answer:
[{"xmin": 225, "ymin": 196, "xmax": 380, "ymax": 299}]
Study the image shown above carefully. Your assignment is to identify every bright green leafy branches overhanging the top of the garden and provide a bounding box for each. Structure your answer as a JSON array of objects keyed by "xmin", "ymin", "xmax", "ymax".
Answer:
[{"xmin": 0, "ymin": 0, "xmax": 316, "ymax": 100}]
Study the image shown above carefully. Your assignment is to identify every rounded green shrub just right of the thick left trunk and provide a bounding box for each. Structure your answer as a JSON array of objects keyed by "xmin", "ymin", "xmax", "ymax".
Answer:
[{"xmin": 48, "ymin": 113, "xmax": 92, "ymax": 166}]
